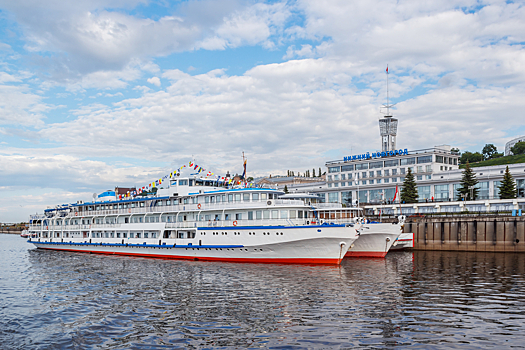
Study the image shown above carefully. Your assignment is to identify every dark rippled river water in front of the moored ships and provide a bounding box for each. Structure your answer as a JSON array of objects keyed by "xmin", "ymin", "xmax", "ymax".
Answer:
[{"xmin": 0, "ymin": 234, "xmax": 525, "ymax": 349}]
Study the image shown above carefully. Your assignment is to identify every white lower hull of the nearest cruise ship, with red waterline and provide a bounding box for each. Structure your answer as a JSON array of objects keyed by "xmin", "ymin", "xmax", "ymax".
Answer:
[{"xmin": 31, "ymin": 227, "xmax": 357, "ymax": 264}]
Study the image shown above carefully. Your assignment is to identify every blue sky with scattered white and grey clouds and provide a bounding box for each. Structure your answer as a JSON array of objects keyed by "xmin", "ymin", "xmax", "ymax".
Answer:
[{"xmin": 0, "ymin": 0, "xmax": 525, "ymax": 222}]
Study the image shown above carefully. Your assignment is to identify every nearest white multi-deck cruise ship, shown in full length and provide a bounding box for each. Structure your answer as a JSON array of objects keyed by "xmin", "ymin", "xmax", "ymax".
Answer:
[{"xmin": 25, "ymin": 171, "xmax": 358, "ymax": 264}]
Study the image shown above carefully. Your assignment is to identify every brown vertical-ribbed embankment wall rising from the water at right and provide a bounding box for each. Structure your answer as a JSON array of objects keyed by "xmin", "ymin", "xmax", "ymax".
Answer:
[{"xmin": 404, "ymin": 216, "xmax": 525, "ymax": 252}]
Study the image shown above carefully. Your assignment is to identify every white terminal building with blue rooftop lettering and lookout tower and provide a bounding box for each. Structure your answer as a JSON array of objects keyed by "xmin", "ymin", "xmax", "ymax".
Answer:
[{"xmin": 280, "ymin": 110, "xmax": 525, "ymax": 214}]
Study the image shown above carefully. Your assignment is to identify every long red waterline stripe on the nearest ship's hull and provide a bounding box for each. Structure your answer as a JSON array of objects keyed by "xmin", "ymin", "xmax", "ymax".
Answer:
[{"xmin": 35, "ymin": 247, "xmax": 341, "ymax": 265}]
